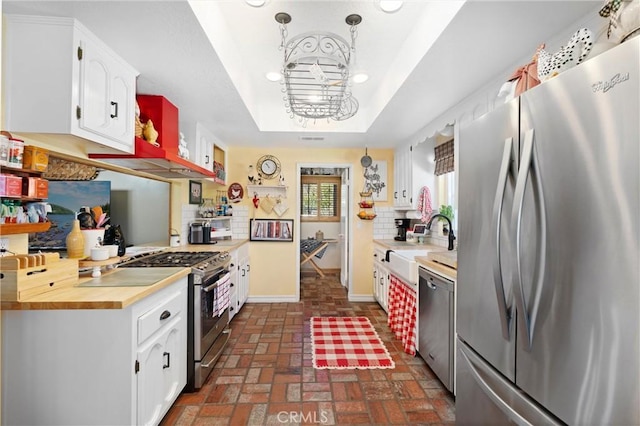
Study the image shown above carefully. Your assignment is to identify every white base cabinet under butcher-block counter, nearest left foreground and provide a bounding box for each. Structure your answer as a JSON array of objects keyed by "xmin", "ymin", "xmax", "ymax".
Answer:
[{"xmin": 2, "ymin": 277, "xmax": 187, "ymax": 425}]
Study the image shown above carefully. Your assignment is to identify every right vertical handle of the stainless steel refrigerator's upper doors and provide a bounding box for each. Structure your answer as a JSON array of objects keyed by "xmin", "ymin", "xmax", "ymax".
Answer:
[{"xmin": 511, "ymin": 129, "xmax": 547, "ymax": 351}]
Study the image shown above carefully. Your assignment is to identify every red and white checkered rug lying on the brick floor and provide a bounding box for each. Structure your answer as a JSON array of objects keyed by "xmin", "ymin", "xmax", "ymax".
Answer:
[{"xmin": 311, "ymin": 317, "xmax": 395, "ymax": 369}]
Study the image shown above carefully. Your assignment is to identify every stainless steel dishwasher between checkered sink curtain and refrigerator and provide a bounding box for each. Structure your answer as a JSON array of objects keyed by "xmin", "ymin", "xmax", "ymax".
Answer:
[{"xmin": 418, "ymin": 267, "xmax": 455, "ymax": 392}]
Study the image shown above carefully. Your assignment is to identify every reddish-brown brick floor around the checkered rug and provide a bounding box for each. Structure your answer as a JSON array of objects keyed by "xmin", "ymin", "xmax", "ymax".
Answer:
[{"xmin": 161, "ymin": 276, "xmax": 455, "ymax": 426}]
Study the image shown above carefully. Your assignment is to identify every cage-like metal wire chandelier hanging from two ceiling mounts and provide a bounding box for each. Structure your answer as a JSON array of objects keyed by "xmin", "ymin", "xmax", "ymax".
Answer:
[{"xmin": 275, "ymin": 12, "xmax": 362, "ymax": 125}]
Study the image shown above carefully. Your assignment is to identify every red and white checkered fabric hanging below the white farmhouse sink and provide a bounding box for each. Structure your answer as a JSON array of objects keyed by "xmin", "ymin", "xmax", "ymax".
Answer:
[{"xmin": 387, "ymin": 274, "xmax": 417, "ymax": 355}]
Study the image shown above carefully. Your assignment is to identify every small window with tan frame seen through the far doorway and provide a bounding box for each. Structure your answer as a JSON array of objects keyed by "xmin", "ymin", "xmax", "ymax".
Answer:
[{"xmin": 300, "ymin": 176, "xmax": 341, "ymax": 222}]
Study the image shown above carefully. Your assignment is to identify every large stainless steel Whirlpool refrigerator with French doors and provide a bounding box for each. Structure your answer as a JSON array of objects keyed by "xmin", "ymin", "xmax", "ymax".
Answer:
[{"xmin": 456, "ymin": 37, "xmax": 640, "ymax": 425}]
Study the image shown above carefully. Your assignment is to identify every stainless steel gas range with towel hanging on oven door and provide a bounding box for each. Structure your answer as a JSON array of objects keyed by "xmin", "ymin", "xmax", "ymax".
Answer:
[{"xmin": 118, "ymin": 251, "xmax": 231, "ymax": 392}]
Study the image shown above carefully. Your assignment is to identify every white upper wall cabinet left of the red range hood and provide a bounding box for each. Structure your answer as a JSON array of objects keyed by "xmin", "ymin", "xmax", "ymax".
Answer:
[{"xmin": 2, "ymin": 15, "xmax": 138, "ymax": 153}]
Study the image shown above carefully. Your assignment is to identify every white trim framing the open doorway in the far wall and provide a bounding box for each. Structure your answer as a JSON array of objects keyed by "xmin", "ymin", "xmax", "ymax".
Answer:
[{"xmin": 294, "ymin": 163, "xmax": 354, "ymax": 301}]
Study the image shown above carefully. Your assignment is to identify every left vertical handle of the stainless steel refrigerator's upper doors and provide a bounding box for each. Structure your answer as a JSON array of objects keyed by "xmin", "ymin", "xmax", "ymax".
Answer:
[{"xmin": 491, "ymin": 138, "xmax": 513, "ymax": 340}]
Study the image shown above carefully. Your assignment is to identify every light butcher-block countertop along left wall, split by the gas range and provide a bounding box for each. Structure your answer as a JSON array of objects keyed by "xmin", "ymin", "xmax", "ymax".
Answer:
[{"xmin": 0, "ymin": 240, "xmax": 248, "ymax": 310}]
